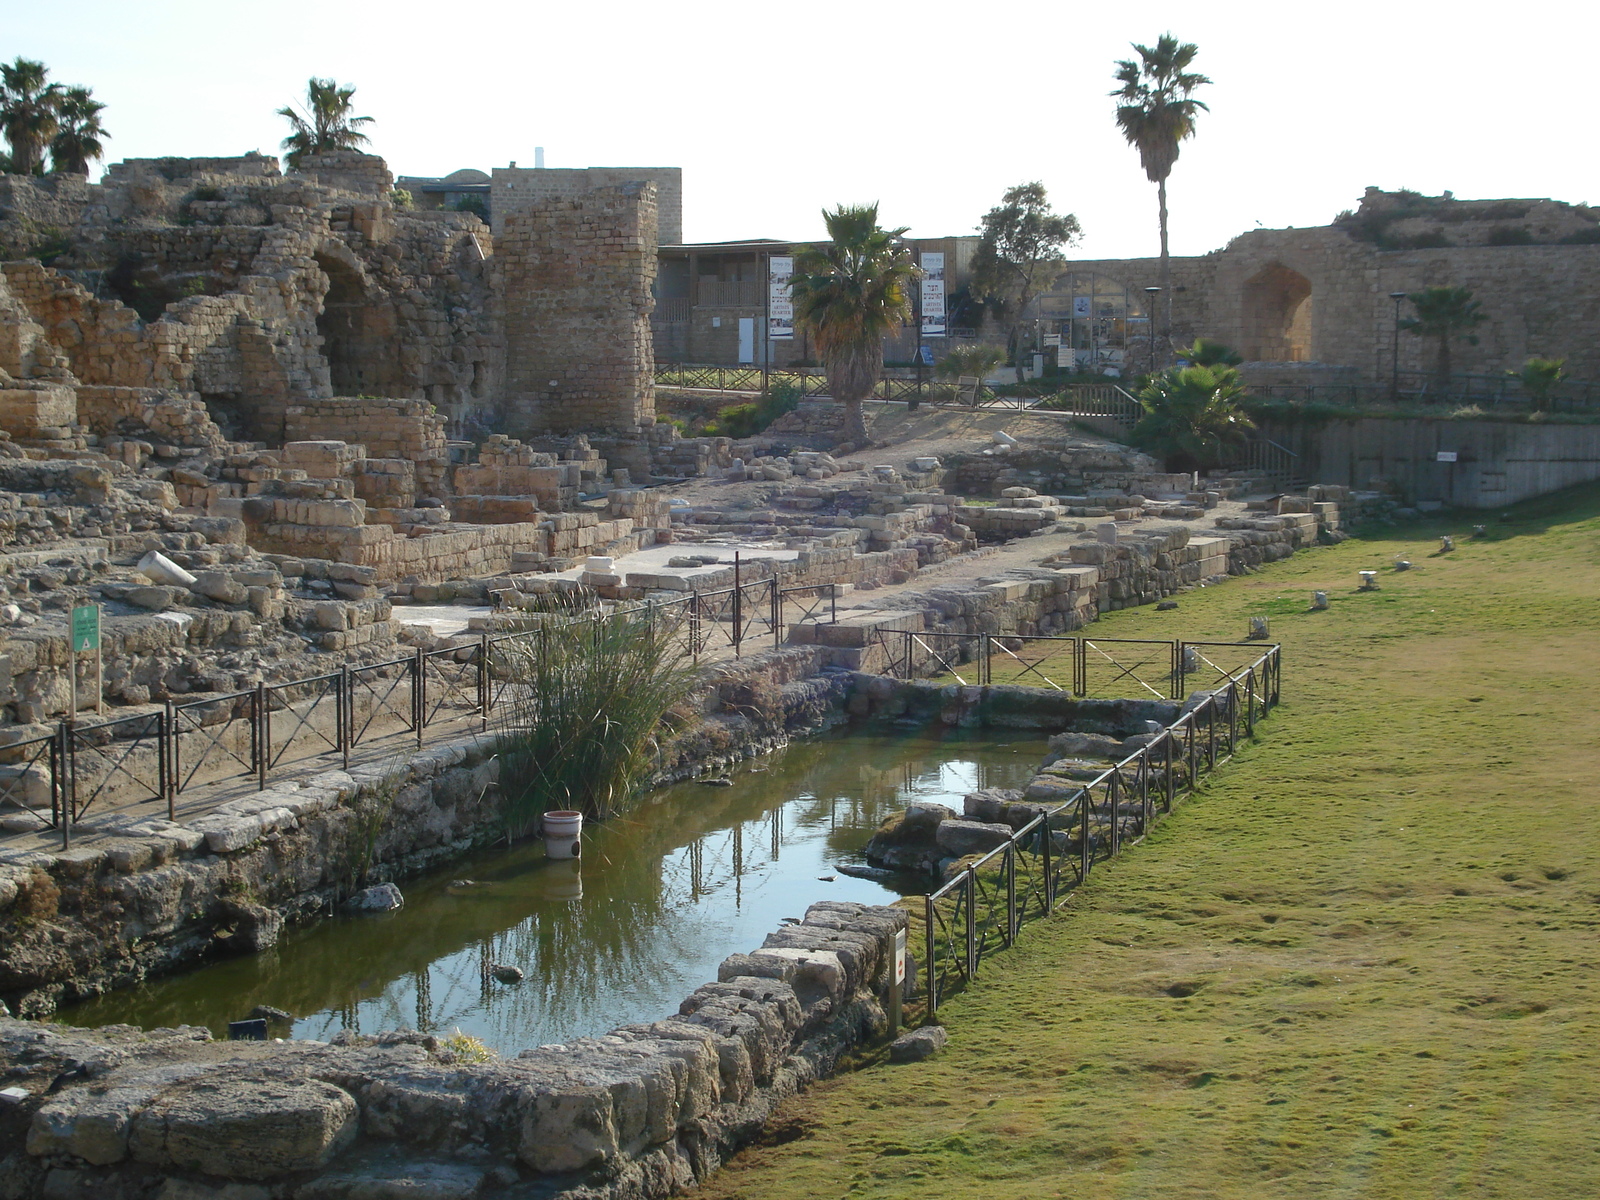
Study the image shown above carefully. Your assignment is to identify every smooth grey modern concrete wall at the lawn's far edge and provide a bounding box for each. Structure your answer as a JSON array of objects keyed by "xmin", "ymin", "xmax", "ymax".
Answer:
[{"xmin": 1262, "ymin": 418, "xmax": 1600, "ymax": 509}]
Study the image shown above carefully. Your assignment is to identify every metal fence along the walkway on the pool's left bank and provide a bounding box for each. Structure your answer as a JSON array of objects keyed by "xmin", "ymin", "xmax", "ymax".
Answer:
[{"xmin": 0, "ymin": 570, "xmax": 838, "ymax": 848}]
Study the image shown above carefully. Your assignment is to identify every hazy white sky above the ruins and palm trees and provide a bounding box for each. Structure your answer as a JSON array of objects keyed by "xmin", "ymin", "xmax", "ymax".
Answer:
[{"xmin": 9, "ymin": 0, "xmax": 1600, "ymax": 258}]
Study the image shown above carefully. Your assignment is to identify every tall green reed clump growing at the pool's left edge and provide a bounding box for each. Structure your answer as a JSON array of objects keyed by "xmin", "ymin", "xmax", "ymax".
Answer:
[{"xmin": 491, "ymin": 597, "xmax": 691, "ymax": 838}]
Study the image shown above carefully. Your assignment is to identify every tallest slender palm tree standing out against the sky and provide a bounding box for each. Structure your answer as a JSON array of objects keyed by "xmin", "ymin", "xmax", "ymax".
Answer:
[{"xmin": 1110, "ymin": 34, "xmax": 1211, "ymax": 355}]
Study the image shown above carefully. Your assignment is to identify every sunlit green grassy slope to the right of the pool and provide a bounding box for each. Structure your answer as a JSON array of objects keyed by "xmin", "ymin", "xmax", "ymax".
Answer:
[{"xmin": 701, "ymin": 488, "xmax": 1600, "ymax": 1200}]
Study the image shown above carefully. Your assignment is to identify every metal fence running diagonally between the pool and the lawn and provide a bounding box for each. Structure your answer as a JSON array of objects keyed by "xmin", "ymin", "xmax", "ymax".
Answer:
[{"xmin": 922, "ymin": 642, "xmax": 1282, "ymax": 1018}]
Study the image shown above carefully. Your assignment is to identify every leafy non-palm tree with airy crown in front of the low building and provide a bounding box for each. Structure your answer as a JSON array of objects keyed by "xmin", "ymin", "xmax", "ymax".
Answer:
[{"xmin": 973, "ymin": 181, "xmax": 1083, "ymax": 371}]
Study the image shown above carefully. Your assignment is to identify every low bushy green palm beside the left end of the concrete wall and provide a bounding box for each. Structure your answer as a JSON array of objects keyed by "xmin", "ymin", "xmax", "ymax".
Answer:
[{"xmin": 1128, "ymin": 365, "xmax": 1254, "ymax": 470}]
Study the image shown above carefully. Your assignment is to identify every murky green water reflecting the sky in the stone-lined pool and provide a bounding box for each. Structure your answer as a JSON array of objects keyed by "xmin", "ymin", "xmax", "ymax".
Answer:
[{"xmin": 61, "ymin": 731, "xmax": 1045, "ymax": 1053}]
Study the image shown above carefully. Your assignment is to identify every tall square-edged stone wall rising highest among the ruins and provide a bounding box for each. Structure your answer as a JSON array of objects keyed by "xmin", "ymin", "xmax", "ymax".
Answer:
[{"xmin": 494, "ymin": 184, "xmax": 656, "ymax": 437}]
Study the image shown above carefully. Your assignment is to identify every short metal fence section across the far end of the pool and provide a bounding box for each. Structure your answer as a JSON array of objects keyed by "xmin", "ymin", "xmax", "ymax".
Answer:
[{"xmin": 867, "ymin": 629, "xmax": 1277, "ymax": 699}]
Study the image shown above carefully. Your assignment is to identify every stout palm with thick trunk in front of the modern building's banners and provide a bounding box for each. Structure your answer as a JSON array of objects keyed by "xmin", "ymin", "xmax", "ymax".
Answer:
[{"xmin": 792, "ymin": 203, "xmax": 917, "ymax": 445}]
